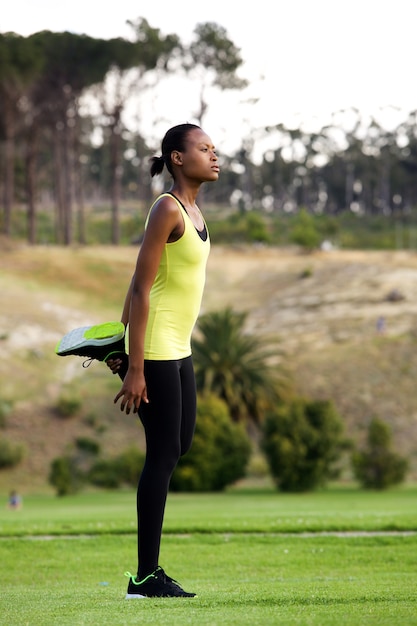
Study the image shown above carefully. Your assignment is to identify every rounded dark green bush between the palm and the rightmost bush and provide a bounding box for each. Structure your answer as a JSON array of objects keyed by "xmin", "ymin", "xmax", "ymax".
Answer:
[{"xmin": 261, "ymin": 398, "xmax": 346, "ymax": 492}]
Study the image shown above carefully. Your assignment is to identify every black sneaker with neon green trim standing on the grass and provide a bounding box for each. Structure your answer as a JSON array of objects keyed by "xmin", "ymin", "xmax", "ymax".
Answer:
[{"xmin": 125, "ymin": 566, "xmax": 196, "ymax": 600}]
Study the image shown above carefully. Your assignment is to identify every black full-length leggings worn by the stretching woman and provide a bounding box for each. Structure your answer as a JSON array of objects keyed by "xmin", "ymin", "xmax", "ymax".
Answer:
[{"xmin": 133, "ymin": 356, "xmax": 196, "ymax": 579}]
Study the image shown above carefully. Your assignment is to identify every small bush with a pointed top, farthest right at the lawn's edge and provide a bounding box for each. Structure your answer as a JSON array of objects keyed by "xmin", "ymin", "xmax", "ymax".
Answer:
[{"xmin": 352, "ymin": 417, "xmax": 409, "ymax": 489}]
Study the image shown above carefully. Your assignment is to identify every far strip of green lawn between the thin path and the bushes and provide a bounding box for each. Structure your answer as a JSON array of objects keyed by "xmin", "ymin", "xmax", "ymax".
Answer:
[{"xmin": 0, "ymin": 486, "xmax": 417, "ymax": 537}]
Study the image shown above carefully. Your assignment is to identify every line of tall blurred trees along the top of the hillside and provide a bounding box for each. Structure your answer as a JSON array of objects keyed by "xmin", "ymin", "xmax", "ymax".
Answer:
[{"xmin": 0, "ymin": 18, "xmax": 417, "ymax": 245}]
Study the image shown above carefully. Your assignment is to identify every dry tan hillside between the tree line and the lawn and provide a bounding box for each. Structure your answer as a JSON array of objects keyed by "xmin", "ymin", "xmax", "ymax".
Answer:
[{"xmin": 0, "ymin": 241, "xmax": 417, "ymax": 492}]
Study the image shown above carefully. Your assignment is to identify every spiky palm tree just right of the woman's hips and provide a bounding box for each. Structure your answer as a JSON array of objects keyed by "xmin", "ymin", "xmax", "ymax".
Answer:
[{"xmin": 193, "ymin": 307, "xmax": 283, "ymax": 424}]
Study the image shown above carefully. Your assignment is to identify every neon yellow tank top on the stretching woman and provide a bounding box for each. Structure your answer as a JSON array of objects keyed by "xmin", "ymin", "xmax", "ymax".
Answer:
[{"xmin": 145, "ymin": 193, "xmax": 210, "ymax": 361}]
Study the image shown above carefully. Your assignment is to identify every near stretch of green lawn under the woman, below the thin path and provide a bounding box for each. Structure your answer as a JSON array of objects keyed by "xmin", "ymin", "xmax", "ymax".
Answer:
[{"xmin": 0, "ymin": 534, "xmax": 417, "ymax": 626}]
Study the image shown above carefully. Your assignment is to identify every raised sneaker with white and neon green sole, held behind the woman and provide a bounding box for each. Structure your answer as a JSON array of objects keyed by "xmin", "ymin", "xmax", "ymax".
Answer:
[{"xmin": 55, "ymin": 322, "xmax": 127, "ymax": 362}]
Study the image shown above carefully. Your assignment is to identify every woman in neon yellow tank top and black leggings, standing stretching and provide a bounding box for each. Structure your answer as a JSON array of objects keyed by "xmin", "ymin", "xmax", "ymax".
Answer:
[{"xmin": 108, "ymin": 124, "xmax": 219, "ymax": 598}]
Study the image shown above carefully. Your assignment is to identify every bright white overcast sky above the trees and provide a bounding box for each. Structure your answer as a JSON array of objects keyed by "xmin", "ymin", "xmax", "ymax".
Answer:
[{"xmin": 0, "ymin": 0, "xmax": 417, "ymax": 155}]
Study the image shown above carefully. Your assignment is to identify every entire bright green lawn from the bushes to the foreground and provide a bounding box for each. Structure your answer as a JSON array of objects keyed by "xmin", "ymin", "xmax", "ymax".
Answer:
[{"xmin": 0, "ymin": 487, "xmax": 417, "ymax": 626}]
